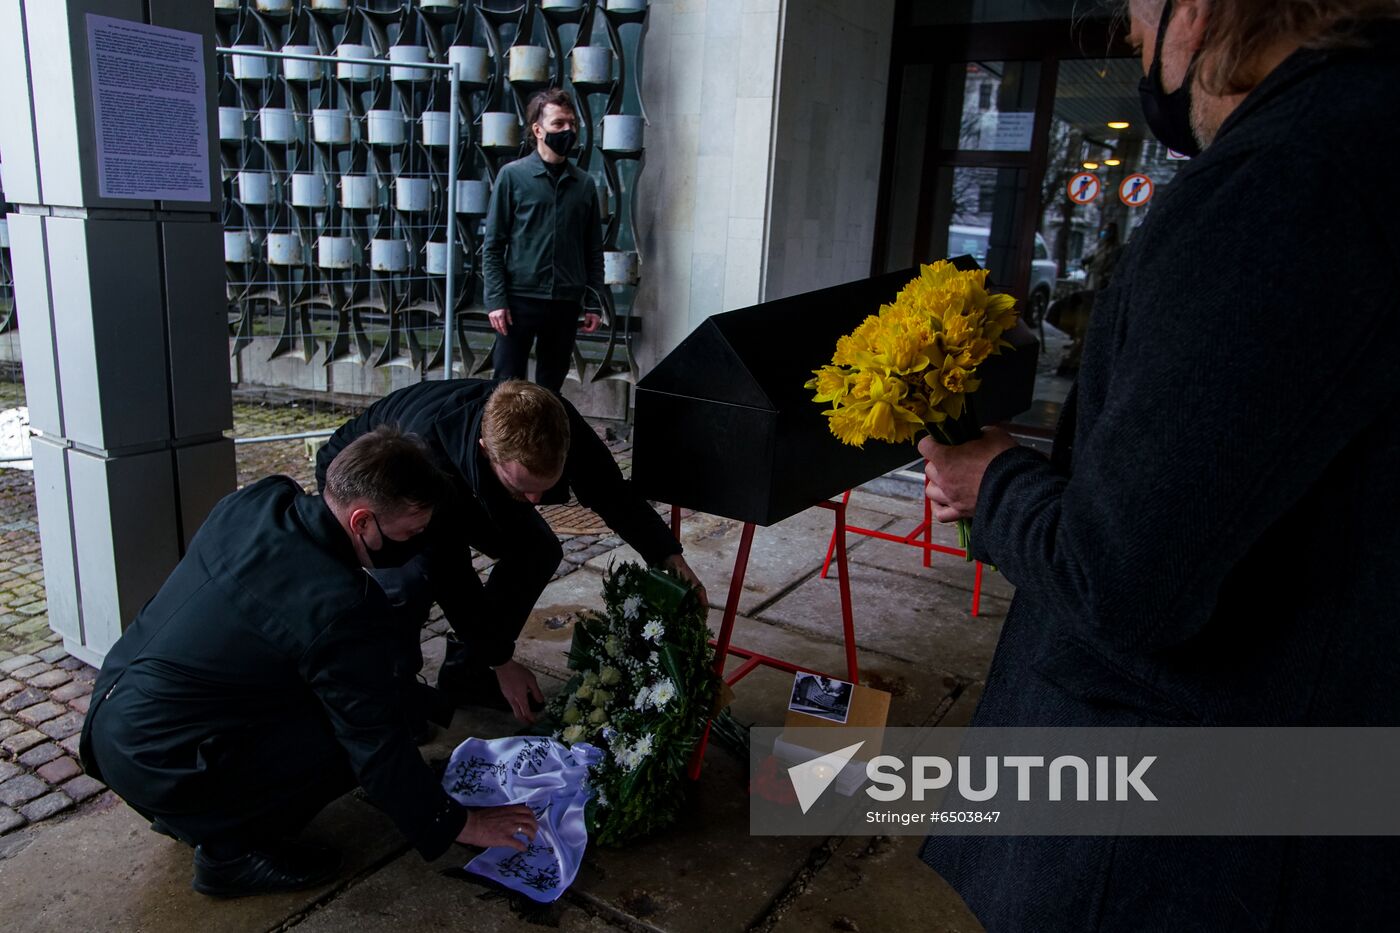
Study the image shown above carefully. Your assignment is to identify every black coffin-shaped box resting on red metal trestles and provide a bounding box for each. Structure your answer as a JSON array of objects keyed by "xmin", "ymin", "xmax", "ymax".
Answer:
[{"xmin": 631, "ymin": 258, "xmax": 1037, "ymax": 525}]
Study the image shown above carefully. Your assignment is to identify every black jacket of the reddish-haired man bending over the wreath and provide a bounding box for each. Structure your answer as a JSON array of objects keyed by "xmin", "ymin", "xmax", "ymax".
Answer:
[{"xmin": 316, "ymin": 380, "xmax": 680, "ymax": 665}]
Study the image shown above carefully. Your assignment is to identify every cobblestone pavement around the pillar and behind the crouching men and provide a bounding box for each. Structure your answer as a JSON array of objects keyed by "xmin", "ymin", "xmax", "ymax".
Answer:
[{"xmin": 0, "ymin": 381, "xmax": 631, "ymax": 836}]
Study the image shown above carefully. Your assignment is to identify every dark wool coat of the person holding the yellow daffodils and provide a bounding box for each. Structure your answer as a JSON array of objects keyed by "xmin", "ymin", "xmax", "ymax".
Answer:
[{"xmin": 924, "ymin": 34, "xmax": 1400, "ymax": 932}]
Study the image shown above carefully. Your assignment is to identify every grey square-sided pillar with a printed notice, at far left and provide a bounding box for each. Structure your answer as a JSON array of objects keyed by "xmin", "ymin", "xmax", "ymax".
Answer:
[{"xmin": 0, "ymin": 0, "xmax": 235, "ymax": 664}]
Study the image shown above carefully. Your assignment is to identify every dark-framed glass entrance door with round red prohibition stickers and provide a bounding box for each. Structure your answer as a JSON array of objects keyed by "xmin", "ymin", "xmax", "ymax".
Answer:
[{"xmin": 872, "ymin": 9, "xmax": 1182, "ymax": 437}]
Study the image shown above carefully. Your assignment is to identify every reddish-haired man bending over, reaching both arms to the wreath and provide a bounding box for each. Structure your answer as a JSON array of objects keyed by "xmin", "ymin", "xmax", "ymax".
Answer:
[{"xmin": 316, "ymin": 380, "xmax": 707, "ymax": 723}]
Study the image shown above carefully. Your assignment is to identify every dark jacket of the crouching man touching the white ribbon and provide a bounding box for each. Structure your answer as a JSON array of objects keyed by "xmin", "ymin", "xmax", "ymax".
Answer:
[{"xmin": 81, "ymin": 476, "xmax": 466, "ymax": 859}]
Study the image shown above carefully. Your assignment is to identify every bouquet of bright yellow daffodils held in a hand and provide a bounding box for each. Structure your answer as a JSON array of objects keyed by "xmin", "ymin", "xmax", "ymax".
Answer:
[{"xmin": 806, "ymin": 261, "xmax": 1019, "ymax": 549}]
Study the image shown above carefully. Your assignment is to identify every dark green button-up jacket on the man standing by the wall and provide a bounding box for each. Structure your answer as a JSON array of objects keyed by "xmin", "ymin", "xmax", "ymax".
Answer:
[{"xmin": 482, "ymin": 151, "xmax": 603, "ymax": 311}]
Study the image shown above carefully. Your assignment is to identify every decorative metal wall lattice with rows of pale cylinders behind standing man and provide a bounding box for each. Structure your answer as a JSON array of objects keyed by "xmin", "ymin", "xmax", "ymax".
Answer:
[{"xmin": 214, "ymin": 0, "xmax": 647, "ymax": 381}]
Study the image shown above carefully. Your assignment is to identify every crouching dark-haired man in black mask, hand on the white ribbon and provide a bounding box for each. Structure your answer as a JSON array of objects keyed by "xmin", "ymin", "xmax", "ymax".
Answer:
[{"xmin": 81, "ymin": 426, "xmax": 536, "ymax": 897}]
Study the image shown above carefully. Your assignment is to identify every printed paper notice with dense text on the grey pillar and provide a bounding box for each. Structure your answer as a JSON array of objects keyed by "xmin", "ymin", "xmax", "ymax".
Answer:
[{"xmin": 87, "ymin": 13, "xmax": 209, "ymax": 200}]
